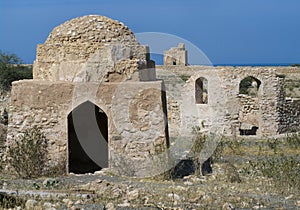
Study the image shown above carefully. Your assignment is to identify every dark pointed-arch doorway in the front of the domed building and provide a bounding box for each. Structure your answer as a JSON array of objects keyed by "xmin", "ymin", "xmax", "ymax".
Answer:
[{"xmin": 68, "ymin": 101, "xmax": 108, "ymax": 174}]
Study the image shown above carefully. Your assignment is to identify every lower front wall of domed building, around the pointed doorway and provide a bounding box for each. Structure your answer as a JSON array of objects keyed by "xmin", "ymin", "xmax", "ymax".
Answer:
[{"xmin": 7, "ymin": 80, "xmax": 167, "ymax": 176}]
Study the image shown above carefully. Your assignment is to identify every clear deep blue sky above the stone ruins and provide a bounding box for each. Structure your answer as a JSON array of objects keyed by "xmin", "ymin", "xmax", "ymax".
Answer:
[{"xmin": 0, "ymin": 0, "xmax": 300, "ymax": 64}]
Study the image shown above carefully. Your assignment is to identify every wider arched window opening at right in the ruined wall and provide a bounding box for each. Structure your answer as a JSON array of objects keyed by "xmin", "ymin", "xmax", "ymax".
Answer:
[{"xmin": 239, "ymin": 76, "xmax": 261, "ymax": 97}]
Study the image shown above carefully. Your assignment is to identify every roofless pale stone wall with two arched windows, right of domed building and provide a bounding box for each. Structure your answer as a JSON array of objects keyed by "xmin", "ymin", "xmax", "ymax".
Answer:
[{"xmin": 156, "ymin": 66, "xmax": 300, "ymax": 136}]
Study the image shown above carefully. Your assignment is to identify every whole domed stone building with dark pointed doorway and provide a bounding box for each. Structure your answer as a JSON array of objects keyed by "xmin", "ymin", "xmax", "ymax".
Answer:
[{"xmin": 7, "ymin": 16, "xmax": 168, "ymax": 176}]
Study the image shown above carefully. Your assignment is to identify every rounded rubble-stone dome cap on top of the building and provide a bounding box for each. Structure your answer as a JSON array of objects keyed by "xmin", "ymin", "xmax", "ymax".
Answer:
[{"xmin": 45, "ymin": 15, "xmax": 139, "ymax": 45}]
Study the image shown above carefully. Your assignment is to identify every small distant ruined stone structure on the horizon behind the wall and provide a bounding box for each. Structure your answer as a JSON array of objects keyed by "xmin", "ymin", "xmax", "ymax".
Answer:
[{"xmin": 164, "ymin": 43, "xmax": 188, "ymax": 66}]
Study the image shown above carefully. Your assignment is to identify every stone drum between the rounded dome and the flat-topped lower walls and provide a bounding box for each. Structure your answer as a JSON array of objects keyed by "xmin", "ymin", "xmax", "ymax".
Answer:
[{"xmin": 33, "ymin": 45, "xmax": 150, "ymax": 82}]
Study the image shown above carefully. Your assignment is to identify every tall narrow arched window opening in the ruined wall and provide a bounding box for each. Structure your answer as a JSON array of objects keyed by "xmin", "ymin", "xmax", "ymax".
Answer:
[{"xmin": 195, "ymin": 77, "xmax": 208, "ymax": 104}]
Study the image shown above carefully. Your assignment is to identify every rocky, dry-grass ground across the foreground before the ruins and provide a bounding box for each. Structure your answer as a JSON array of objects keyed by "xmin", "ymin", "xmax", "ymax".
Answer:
[{"xmin": 0, "ymin": 136, "xmax": 300, "ymax": 210}]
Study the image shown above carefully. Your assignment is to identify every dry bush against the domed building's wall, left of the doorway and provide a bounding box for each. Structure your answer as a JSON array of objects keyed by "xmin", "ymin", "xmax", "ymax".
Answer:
[{"xmin": 7, "ymin": 127, "xmax": 48, "ymax": 178}]
